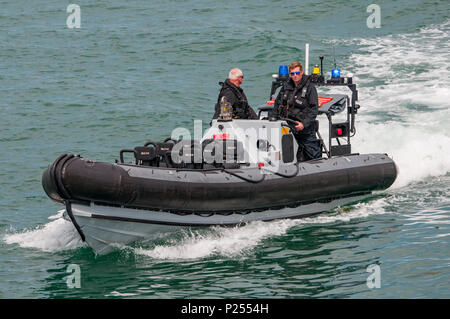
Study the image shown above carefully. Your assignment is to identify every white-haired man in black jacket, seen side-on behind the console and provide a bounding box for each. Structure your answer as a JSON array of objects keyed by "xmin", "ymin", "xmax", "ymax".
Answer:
[{"xmin": 213, "ymin": 68, "xmax": 258, "ymax": 120}]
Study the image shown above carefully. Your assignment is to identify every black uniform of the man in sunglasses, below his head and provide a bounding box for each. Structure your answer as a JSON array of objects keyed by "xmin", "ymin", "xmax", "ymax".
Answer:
[{"xmin": 272, "ymin": 75, "xmax": 322, "ymax": 161}]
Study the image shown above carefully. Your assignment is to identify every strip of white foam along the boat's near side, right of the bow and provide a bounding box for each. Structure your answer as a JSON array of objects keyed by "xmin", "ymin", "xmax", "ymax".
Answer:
[{"xmin": 134, "ymin": 198, "xmax": 389, "ymax": 260}]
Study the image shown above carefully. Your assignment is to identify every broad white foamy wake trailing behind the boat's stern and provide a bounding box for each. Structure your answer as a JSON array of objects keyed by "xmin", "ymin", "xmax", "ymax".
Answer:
[{"xmin": 340, "ymin": 21, "xmax": 450, "ymax": 188}]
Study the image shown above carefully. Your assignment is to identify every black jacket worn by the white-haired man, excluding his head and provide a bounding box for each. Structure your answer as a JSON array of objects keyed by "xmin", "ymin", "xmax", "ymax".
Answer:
[{"xmin": 213, "ymin": 79, "xmax": 258, "ymax": 120}]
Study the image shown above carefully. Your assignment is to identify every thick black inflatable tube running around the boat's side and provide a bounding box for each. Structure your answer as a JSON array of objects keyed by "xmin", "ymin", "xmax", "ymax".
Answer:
[{"xmin": 42, "ymin": 155, "xmax": 397, "ymax": 213}]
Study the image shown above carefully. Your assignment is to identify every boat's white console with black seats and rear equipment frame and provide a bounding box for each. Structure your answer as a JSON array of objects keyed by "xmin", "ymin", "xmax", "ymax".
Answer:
[{"xmin": 116, "ymin": 61, "xmax": 359, "ymax": 169}]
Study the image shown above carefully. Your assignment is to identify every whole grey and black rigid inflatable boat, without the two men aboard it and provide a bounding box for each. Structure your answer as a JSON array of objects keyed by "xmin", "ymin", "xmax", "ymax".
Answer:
[{"xmin": 42, "ymin": 65, "xmax": 397, "ymax": 254}]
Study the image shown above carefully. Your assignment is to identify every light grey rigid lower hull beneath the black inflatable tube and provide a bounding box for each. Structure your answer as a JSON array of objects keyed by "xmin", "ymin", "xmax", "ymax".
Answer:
[{"xmin": 64, "ymin": 194, "xmax": 369, "ymax": 255}]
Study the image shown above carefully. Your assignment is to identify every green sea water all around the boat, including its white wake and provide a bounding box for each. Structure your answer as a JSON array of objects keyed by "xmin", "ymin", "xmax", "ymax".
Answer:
[{"xmin": 0, "ymin": 0, "xmax": 450, "ymax": 298}]
